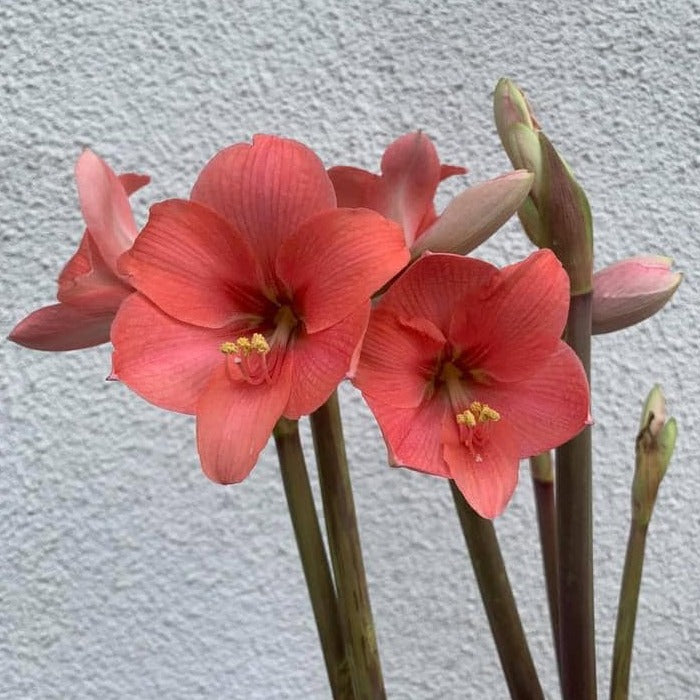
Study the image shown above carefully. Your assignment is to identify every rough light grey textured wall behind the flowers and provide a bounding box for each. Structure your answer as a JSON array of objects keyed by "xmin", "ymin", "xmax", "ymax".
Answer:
[{"xmin": 0, "ymin": 0, "xmax": 700, "ymax": 699}]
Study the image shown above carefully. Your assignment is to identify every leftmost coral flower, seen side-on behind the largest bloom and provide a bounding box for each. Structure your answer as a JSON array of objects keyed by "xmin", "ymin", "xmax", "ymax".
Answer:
[{"xmin": 9, "ymin": 151, "xmax": 150, "ymax": 350}]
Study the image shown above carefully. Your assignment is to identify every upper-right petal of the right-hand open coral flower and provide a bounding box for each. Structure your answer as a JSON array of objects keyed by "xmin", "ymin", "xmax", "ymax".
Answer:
[{"xmin": 449, "ymin": 250, "xmax": 569, "ymax": 381}]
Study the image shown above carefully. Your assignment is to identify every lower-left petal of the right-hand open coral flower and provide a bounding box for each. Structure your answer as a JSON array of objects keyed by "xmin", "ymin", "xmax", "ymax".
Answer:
[{"xmin": 358, "ymin": 395, "xmax": 451, "ymax": 477}]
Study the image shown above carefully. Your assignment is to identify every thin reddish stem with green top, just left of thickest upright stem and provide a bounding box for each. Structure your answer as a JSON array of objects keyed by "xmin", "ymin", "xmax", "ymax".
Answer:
[{"xmin": 530, "ymin": 452, "xmax": 561, "ymax": 678}]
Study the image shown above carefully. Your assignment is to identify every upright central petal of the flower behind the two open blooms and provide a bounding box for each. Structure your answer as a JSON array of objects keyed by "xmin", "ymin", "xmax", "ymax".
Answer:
[{"xmin": 381, "ymin": 131, "xmax": 440, "ymax": 245}]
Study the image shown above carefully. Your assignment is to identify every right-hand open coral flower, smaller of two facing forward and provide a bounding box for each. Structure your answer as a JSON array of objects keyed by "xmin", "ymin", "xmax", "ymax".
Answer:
[{"xmin": 354, "ymin": 250, "xmax": 589, "ymax": 518}]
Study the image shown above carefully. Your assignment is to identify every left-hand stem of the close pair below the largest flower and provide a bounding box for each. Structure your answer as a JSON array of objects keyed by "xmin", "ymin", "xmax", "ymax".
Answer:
[{"xmin": 274, "ymin": 418, "xmax": 354, "ymax": 700}]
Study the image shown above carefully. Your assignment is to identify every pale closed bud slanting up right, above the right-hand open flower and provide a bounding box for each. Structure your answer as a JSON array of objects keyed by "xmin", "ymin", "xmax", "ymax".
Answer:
[{"xmin": 411, "ymin": 170, "xmax": 533, "ymax": 257}]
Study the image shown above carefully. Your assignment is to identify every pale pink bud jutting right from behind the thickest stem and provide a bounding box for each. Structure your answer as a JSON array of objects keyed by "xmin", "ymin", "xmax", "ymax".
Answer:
[{"xmin": 593, "ymin": 255, "xmax": 683, "ymax": 334}]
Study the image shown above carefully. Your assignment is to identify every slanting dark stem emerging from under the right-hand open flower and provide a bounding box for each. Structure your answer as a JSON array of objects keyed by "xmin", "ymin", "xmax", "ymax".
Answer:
[{"xmin": 450, "ymin": 481, "xmax": 544, "ymax": 700}]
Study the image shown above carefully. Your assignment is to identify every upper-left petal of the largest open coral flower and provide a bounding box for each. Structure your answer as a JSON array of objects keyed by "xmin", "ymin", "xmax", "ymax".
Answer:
[{"xmin": 119, "ymin": 199, "xmax": 269, "ymax": 328}]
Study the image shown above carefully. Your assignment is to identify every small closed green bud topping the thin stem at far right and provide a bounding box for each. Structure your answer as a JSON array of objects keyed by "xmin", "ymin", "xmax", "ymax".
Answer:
[{"xmin": 632, "ymin": 384, "xmax": 678, "ymax": 525}]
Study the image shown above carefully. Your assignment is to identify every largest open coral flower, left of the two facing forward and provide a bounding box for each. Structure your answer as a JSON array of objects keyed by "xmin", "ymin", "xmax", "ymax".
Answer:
[{"xmin": 112, "ymin": 136, "xmax": 409, "ymax": 483}]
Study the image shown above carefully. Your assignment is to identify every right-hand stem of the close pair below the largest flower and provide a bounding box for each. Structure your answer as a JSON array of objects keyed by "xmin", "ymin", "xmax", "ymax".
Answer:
[{"xmin": 311, "ymin": 392, "xmax": 386, "ymax": 700}]
